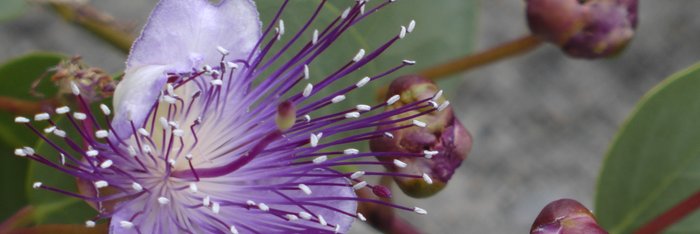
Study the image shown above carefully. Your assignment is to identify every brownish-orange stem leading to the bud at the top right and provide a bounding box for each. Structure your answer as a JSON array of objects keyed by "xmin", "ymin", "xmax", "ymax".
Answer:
[{"xmin": 419, "ymin": 35, "xmax": 542, "ymax": 80}]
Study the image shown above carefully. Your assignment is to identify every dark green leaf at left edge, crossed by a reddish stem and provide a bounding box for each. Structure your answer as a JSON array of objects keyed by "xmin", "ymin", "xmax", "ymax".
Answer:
[{"xmin": 0, "ymin": 53, "xmax": 63, "ymax": 220}]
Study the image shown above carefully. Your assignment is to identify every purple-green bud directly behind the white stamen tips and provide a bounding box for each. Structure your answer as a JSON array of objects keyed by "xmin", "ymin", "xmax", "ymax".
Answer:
[{"xmin": 370, "ymin": 75, "xmax": 472, "ymax": 197}]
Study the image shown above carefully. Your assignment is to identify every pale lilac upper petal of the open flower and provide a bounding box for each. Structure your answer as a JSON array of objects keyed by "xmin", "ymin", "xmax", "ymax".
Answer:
[{"xmin": 126, "ymin": 0, "xmax": 261, "ymax": 71}]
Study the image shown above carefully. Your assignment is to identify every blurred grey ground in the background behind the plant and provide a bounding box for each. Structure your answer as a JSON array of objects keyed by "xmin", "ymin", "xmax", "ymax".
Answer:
[{"xmin": 0, "ymin": 0, "xmax": 700, "ymax": 233}]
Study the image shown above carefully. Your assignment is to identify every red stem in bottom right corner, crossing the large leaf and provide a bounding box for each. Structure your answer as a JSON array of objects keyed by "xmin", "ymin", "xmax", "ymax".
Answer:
[{"xmin": 634, "ymin": 191, "xmax": 700, "ymax": 234}]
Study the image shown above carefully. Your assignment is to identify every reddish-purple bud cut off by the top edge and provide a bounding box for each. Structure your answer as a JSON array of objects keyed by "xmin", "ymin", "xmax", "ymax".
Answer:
[{"xmin": 527, "ymin": 0, "xmax": 637, "ymax": 58}]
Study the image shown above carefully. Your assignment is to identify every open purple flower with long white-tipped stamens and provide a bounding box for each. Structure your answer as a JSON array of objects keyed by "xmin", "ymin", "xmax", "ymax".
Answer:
[{"xmin": 15, "ymin": 0, "xmax": 448, "ymax": 233}]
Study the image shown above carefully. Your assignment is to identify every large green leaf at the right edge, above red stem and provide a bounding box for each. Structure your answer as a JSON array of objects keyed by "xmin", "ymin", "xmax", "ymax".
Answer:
[{"xmin": 595, "ymin": 64, "xmax": 700, "ymax": 233}]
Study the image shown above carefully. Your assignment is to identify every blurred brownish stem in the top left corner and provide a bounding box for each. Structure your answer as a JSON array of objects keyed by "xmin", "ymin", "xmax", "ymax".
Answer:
[{"xmin": 50, "ymin": 3, "xmax": 134, "ymax": 53}]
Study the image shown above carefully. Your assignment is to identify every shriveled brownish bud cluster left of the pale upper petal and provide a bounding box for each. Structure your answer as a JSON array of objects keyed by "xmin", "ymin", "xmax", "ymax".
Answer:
[{"xmin": 32, "ymin": 56, "xmax": 116, "ymax": 102}]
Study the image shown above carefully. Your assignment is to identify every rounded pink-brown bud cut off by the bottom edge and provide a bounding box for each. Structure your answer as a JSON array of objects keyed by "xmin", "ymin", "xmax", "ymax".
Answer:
[{"xmin": 530, "ymin": 199, "xmax": 608, "ymax": 234}]
